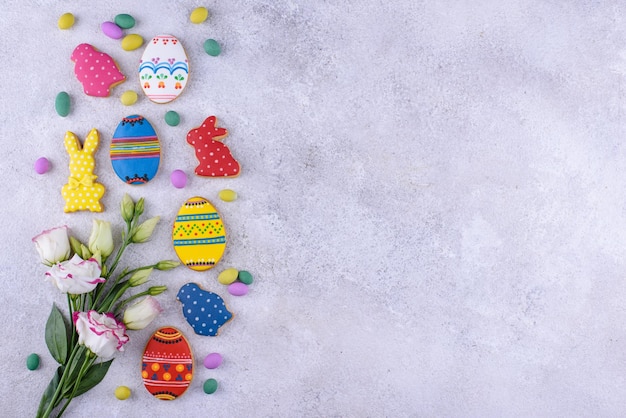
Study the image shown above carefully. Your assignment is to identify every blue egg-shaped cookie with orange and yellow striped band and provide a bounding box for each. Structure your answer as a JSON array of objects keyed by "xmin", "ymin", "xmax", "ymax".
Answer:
[{"xmin": 110, "ymin": 115, "xmax": 161, "ymax": 184}]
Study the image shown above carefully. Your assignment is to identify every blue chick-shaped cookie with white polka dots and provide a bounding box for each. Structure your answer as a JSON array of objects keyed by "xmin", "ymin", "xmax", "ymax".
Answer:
[{"xmin": 176, "ymin": 283, "xmax": 233, "ymax": 337}]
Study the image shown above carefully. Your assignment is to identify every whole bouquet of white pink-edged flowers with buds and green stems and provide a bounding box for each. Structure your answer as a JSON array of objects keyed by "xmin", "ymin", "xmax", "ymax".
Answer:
[{"xmin": 33, "ymin": 195, "xmax": 179, "ymax": 417}]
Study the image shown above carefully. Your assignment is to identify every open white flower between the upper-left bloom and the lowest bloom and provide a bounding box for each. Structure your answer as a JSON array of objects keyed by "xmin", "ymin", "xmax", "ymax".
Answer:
[{"xmin": 46, "ymin": 254, "xmax": 104, "ymax": 295}]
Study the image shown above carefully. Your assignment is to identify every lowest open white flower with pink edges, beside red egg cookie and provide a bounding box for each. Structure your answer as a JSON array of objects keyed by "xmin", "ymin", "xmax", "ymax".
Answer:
[{"xmin": 72, "ymin": 310, "xmax": 129, "ymax": 358}]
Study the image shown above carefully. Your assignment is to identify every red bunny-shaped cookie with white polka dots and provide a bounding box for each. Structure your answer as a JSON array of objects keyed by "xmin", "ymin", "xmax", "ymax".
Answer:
[{"xmin": 187, "ymin": 116, "xmax": 241, "ymax": 177}]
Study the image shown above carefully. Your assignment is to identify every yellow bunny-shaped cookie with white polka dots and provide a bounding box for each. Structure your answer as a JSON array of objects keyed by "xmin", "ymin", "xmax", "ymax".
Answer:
[{"xmin": 61, "ymin": 129, "xmax": 105, "ymax": 212}]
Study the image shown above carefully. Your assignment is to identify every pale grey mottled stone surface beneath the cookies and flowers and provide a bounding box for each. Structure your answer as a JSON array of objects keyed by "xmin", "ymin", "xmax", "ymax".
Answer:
[{"xmin": 0, "ymin": 0, "xmax": 626, "ymax": 417}]
